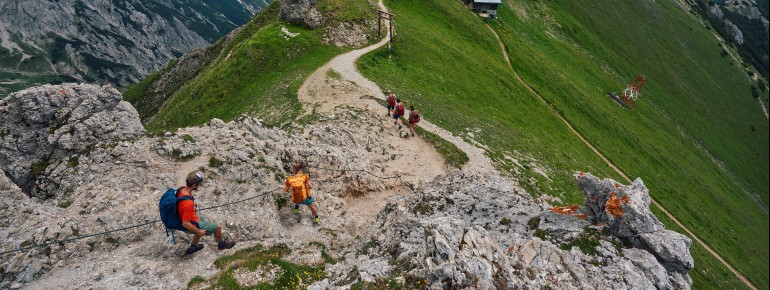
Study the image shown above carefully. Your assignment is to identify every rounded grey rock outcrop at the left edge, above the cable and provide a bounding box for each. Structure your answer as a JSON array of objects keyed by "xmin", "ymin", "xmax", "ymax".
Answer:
[{"xmin": 0, "ymin": 84, "xmax": 144, "ymax": 198}]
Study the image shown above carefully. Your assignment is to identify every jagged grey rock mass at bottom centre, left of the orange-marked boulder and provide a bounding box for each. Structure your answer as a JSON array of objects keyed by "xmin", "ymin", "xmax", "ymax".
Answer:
[{"xmin": 346, "ymin": 173, "xmax": 690, "ymax": 289}]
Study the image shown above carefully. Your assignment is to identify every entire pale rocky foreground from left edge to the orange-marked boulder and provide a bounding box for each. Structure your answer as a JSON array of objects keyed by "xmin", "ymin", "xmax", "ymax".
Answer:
[{"xmin": 0, "ymin": 90, "xmax": 691, "ymax": 289}]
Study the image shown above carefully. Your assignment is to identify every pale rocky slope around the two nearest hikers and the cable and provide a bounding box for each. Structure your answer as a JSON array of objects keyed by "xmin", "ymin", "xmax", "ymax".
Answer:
[{"xmin": 0, "ymin": 108, "xmax": 440, "ymax": 289}]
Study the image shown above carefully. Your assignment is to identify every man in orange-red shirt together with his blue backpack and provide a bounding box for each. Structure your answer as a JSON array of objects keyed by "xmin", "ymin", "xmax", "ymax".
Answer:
[{"xmin": 160, "ymin": 172, "xmax": 235, "ymax": 255}]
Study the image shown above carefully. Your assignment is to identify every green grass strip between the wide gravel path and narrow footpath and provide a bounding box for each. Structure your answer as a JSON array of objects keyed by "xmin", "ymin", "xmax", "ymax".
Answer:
[{"xmin": 359, "ymin": 1, "xmax": 619, "ymax": 202}]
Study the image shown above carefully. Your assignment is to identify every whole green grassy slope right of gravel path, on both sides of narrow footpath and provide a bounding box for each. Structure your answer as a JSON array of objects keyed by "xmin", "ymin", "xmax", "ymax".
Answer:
[{"xmin": 360, "ymin": 0, "xmax": 768, "ymax": 289}]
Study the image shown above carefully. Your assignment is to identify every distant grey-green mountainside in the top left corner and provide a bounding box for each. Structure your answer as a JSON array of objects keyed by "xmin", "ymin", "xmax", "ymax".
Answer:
[{"xmin": 0, "ymin": 0, "xmax": 270, "ymax": 97}]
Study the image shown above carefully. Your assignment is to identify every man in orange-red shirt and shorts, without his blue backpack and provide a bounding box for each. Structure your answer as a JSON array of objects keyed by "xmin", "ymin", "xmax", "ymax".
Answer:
[{"xmin": 176, "ymin": 172, "xmax": 235, "ymax": 254}]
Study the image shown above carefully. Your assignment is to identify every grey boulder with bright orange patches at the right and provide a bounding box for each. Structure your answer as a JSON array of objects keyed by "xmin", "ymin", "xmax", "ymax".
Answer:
[{"xmin": 535, "ymin": 173, "xmax": 694, "ymax": 289}]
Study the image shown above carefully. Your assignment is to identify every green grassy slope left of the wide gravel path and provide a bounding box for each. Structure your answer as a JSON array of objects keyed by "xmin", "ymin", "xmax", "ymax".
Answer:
[{"xmin": 126, "ymin": 0, "xmax": 375, "ymax": 132}]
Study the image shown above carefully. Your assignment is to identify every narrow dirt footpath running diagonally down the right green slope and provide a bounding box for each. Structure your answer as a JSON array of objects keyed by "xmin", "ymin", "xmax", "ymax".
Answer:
[{"xmin": 487, "ymin": 24, "xmax": 764, "ymax": 290}]
